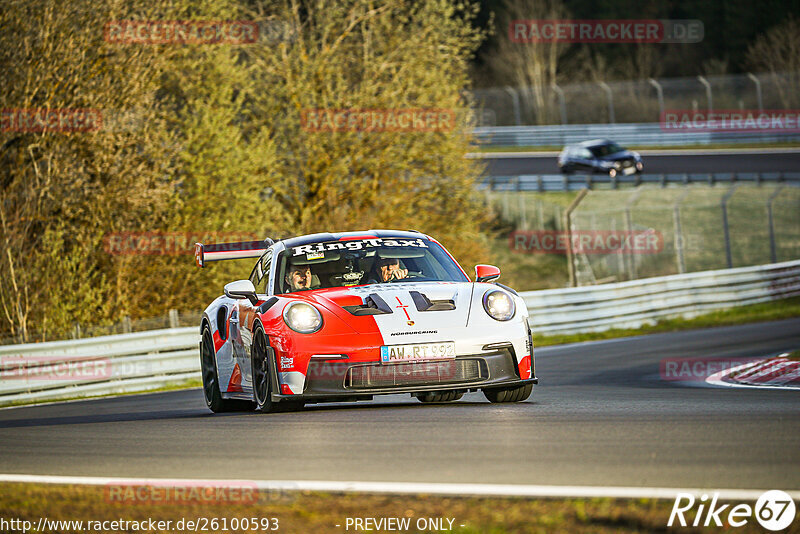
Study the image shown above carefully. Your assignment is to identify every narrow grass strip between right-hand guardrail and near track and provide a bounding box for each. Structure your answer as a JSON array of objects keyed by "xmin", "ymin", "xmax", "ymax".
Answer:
[{"xmin": 534, "ymin": 297, "xmax": 800, "ymax": 347}]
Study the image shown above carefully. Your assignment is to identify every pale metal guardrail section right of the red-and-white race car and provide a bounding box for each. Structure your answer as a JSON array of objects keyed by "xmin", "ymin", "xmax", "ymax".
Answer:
[{"xmin": 520, "ymin": 261, "xmax": 800, "ymax": 335}]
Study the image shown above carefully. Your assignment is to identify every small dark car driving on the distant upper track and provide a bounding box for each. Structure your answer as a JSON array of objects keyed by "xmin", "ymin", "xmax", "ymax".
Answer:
[{"xmin": 558, "ymin": 139, "xmax": 644, "ymax": 178}]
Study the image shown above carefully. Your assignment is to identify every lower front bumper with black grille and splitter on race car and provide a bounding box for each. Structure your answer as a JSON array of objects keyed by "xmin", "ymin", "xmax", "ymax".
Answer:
[{"xmin": 272, "ymin": 347, "xmax": 539, "ymax": 402}]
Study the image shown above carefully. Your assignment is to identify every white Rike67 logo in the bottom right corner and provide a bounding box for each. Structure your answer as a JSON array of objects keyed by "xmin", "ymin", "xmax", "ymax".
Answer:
[{"xmin": 667, "ymin": 490, "xmax": 795, "ymax": 531}]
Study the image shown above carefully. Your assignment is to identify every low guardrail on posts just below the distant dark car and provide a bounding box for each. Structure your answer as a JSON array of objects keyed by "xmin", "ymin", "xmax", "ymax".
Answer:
[{"xmin": 478, "ymin": 173, "xmax": 800, "ymax": 193}]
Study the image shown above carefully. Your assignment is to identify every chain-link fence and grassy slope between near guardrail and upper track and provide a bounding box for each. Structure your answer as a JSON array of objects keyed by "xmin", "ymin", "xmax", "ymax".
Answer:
[{"xmin": 494, "ymin": 184, "xmax": 800, "ymax": 285}]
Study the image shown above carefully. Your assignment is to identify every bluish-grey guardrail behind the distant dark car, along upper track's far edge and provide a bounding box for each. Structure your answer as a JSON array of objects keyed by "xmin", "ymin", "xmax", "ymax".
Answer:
[{"xmin": 472, "ymin": 122, "xmax": 800, "ymax": 147}]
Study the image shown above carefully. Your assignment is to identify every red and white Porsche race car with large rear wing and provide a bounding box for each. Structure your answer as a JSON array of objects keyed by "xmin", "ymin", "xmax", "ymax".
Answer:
[{"xmin": 195, "ymin": 230, "xmax": 538, "ymax": 412}]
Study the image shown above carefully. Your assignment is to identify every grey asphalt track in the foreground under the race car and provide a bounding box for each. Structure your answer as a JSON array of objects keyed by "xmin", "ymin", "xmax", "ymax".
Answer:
[{"xmin": 0, "ymin": 318, "xmax": 800, "ymax": 490}]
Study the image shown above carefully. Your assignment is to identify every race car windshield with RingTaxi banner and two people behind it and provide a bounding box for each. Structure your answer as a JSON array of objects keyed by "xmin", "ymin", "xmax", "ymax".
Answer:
[{"xmin": 276, "ymin": 237, "xmax": 469, "ymax": 294}]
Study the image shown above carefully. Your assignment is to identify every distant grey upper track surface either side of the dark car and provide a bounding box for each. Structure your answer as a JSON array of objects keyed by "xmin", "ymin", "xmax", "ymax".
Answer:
[{"xmin": 484, "ymin": 151, "xmax": 800, "ymax": 176}]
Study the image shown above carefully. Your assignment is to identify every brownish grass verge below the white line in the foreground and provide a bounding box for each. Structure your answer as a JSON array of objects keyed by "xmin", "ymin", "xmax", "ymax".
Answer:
[{"xmin": 0, "ymin": 483, "xmax": 776, "ymax": 534}]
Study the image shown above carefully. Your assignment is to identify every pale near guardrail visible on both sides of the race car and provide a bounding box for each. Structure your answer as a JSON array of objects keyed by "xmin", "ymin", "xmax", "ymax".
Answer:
[{"xmin": 0, "ymin": 261, "xmax": 800, "ymax": 405}]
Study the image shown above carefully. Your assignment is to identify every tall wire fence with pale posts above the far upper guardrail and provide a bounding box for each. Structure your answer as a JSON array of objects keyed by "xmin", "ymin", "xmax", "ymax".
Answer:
[{"xmin": 472, "ymin": 72, "xmax": 800, "ymax": 126}]
